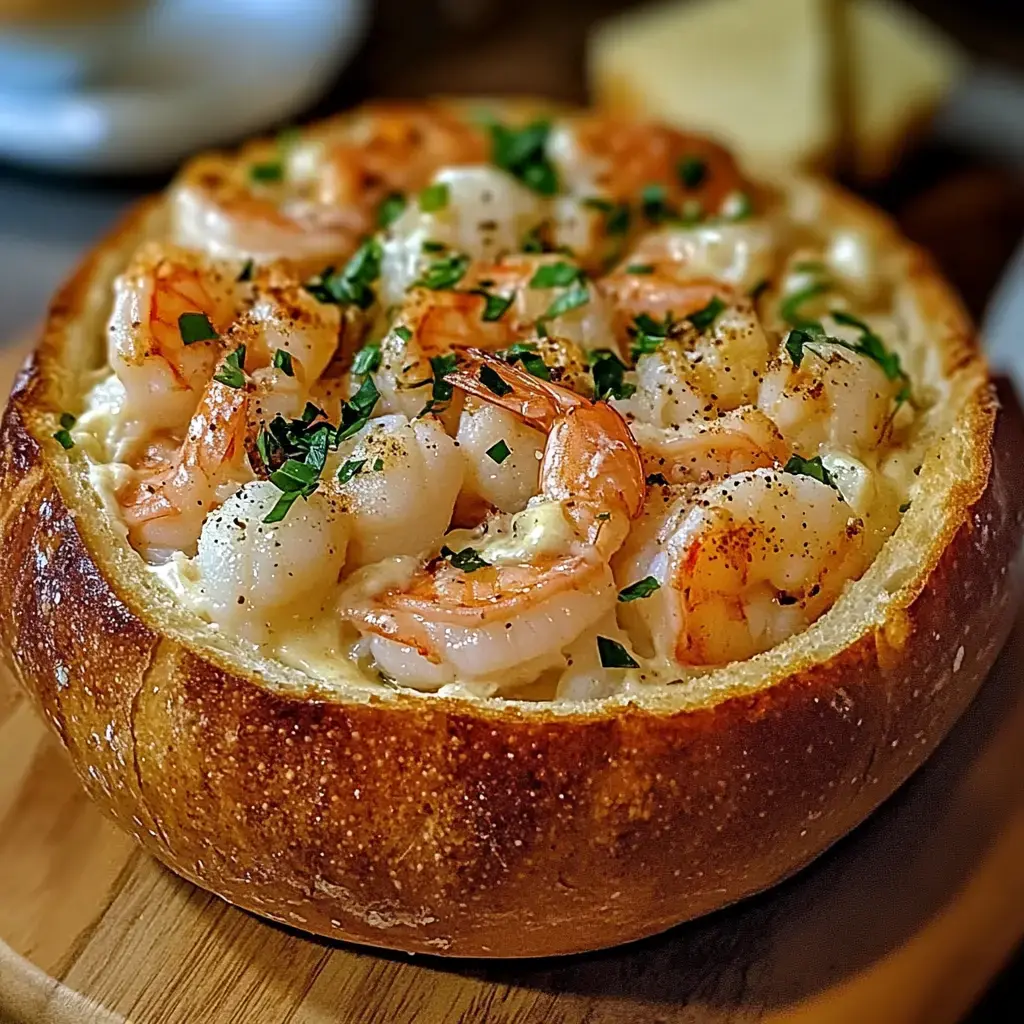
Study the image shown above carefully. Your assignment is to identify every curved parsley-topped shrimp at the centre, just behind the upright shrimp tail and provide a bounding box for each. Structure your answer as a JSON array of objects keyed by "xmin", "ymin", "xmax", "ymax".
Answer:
[{"xmin": 374, "ymin": 255, "xmax": 614, "ymax": 416}]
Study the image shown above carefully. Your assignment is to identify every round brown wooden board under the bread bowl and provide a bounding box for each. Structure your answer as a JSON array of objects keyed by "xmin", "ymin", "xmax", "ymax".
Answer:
[{"xmin": 0, "ymin": 342, "xmax": 1024, "ymax": 1024}]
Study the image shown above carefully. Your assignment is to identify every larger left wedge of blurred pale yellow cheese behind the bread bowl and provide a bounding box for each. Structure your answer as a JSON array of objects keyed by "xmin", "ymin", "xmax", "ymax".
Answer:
[{"xmin": 589, "ymin": 0, "xmax": 838, "ymax": 171}]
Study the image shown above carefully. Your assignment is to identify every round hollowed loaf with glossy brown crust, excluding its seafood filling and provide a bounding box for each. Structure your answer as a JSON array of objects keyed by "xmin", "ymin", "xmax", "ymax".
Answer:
[{"xmin": 0, "ymin": 99, "xmax": 1022, "ymax": 956}]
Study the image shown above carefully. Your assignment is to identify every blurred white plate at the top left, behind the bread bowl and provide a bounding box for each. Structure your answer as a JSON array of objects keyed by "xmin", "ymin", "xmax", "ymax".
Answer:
[{"xmin": 0, "ymin": 0, "xmax": 367, "ymax": 172}]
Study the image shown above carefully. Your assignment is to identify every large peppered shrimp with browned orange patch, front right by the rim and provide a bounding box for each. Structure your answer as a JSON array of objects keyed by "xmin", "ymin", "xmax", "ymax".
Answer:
[{"xmin": 615, "ymin": 469, "xmax": 867, "ymax": 666}]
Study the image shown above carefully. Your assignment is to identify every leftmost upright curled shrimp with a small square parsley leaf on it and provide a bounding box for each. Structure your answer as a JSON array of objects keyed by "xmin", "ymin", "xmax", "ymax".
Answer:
[{"xmin": 108, "ymin": 242, "xmax": 237, "ymax": 430}]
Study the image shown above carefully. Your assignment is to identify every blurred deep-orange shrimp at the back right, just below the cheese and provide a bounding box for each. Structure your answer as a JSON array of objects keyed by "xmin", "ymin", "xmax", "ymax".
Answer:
[{"xmin": 547, "ymin": 114, "xmax": 751, "ymax": 215}]
